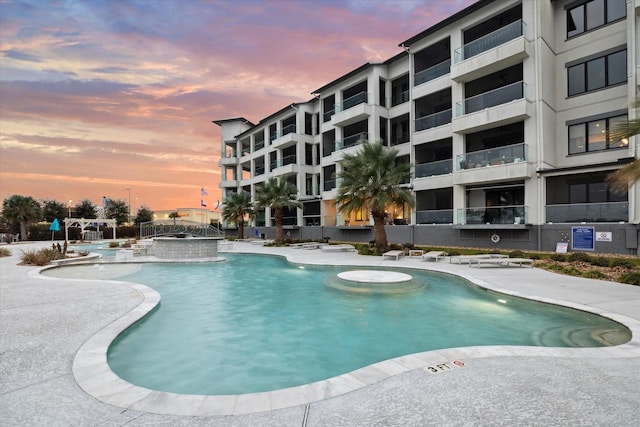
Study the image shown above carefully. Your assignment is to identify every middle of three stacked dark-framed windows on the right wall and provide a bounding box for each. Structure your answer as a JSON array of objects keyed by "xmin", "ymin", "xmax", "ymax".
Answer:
[{"xmin": 567, "ymin": 49, "xmax": 627, "ymax": 96}]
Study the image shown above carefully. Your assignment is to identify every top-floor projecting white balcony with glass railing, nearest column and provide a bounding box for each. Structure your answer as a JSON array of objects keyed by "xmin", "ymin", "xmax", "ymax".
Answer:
[{"xmin": 451, "ymin": 20, "xmax": 529, "ymax": 82}]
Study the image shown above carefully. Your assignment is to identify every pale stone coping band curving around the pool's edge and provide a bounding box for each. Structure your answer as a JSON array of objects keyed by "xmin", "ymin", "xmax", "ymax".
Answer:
[{"xmin": 63, "ymin": 251, "xmax": 640, "ymax": 417}]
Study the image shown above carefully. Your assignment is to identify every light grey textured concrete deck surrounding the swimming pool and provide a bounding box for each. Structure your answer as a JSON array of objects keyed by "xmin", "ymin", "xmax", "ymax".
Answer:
[{"xmin": 0, "ymin": 242, "xmax": 640, "ymax": 426}]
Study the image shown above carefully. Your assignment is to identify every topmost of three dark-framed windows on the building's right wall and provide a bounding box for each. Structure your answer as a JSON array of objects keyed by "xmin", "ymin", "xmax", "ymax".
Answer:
[{"xmin": 567, "ymin": 0, "xmax": 627, "ymax": 38}]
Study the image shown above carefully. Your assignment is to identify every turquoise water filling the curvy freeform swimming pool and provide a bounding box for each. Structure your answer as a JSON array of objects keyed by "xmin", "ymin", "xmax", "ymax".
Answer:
[{"xmin": 95, "ymin": 254, "xmax": 630, "ymax": 395}]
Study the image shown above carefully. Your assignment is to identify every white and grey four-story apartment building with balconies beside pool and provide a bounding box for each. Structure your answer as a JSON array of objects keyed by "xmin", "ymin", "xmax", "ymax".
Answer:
[{"xmin": 214, "ymin": 0, "xmax": 640, "ymax": 254}]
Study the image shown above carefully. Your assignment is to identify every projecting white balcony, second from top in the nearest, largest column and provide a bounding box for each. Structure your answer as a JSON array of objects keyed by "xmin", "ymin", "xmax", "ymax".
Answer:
[{"xmin": 451, "ymin": 82, "xmax": 531, "ymax": 133}]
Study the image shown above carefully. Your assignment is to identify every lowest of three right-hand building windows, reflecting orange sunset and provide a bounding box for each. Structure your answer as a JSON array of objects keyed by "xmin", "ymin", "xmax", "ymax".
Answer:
[{"xmin": 569, "ymin": 115, "xmax": 629, "ymax": 154}]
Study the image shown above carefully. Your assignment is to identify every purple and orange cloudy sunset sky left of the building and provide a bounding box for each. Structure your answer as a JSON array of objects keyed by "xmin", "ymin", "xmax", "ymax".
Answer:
[{"xmin": 0, "ymin": 0, "xmax": 475, "ymax": 212}]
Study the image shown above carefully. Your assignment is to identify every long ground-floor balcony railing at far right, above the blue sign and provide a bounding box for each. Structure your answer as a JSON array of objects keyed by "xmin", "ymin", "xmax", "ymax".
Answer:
[{"xmin": 546, "ymin": 202, "xmax": 629, "ymax": 223}]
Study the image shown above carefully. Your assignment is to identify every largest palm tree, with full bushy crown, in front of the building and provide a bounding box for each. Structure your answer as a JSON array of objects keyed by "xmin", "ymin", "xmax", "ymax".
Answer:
[{"xmin": 336, "ymin": 141, "xmax": 415, "ymax": 250}]
